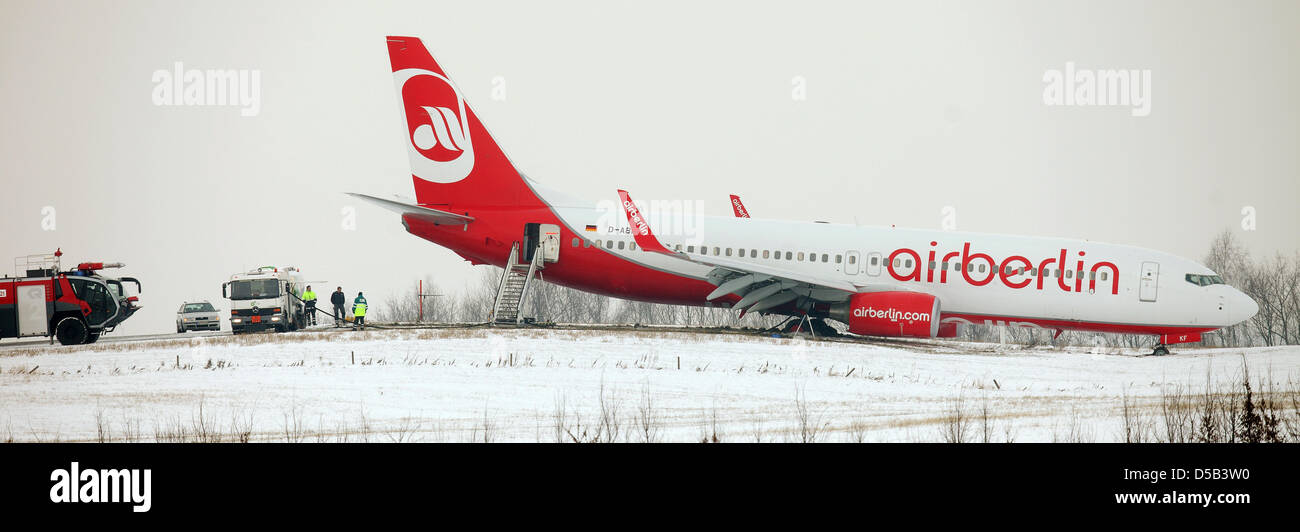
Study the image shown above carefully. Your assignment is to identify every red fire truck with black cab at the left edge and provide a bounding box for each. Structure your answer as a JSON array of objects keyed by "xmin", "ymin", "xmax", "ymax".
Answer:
[{"xmin": 0, "ymin": 250, "xmax": 140, "ymax": 346}]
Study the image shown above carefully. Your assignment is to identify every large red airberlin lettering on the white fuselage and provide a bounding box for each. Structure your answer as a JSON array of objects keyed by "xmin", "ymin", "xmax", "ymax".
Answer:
[{"xmin": 885, "ymin": 242, "xmax": 1119, "ymax": 294}]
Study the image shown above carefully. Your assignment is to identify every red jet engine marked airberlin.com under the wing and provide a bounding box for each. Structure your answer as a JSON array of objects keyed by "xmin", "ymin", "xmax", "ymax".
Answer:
[{"xmin": 829, "ymin": 291, "xmax": 940, "ymax": 338}]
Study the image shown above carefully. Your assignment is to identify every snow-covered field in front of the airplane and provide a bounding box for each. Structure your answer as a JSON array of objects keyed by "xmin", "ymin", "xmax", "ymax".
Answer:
[{"xmin": 0, "ymin": 328, "xmax": 1300, "ymax": 442}]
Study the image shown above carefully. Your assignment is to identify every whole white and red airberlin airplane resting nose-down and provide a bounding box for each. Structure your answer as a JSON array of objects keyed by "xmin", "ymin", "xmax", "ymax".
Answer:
[{"xmin": 356, "ymin": 36, "xmax": 1258, "ymax": 354}]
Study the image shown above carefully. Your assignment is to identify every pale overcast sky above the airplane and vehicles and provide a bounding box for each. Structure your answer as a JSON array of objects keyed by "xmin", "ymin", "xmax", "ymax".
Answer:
[{"xmin": 0, "ymin": 0, "xmax": 1300, "ymax": 333}]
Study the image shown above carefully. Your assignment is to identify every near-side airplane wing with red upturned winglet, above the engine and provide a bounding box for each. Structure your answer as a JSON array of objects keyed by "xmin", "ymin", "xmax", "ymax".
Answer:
[{"xmin": 619, "ymin": 190, "xmax": 884, "ymax": 312}]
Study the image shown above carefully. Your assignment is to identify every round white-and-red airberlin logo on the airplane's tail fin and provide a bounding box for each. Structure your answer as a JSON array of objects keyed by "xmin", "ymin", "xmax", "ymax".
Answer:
[{"xmin": 393, "ymin": 69, "xmax": 475, "ymax": 183}]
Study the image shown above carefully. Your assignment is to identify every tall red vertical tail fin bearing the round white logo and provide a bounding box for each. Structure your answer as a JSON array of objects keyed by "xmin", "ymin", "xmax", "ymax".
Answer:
[{"xmin": 389, "ymin": 36, "xmax": 536, "ymax": 207}]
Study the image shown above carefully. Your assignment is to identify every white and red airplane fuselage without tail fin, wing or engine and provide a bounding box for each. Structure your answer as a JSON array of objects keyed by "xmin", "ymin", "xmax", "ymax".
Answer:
[{"xmin": 408, "ymin": 190, "xmax": 1255, "ymax": 334}]
